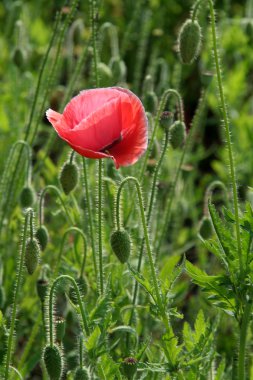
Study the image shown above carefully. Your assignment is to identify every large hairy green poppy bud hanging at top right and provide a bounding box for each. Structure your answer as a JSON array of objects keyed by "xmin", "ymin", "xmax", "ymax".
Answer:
[{"xmin": 178, "ymin": 19, "xmax": 201, "ymax": 64}]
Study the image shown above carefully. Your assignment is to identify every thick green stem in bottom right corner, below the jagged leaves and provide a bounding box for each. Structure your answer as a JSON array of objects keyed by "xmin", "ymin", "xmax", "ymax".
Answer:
[{"xmin": 238, "ymin": 302, "xmax": 252, "ymax": 380}]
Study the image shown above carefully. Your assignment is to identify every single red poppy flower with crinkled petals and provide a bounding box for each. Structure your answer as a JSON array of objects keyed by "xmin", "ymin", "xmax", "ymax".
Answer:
[{"xmin": 46, "ymin": 87, "xmax": 148, "ymax": 168}]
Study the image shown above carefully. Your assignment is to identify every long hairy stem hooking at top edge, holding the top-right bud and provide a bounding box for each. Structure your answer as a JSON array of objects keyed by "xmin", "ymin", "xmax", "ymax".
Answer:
[{"xmin": 192, "ymin": 0, "xmax": 243, "ymax": 276}]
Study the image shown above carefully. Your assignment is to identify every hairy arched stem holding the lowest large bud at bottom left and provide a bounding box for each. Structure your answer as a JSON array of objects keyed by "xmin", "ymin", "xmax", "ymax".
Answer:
[{"xmin": 49, "ymin": 275, "xmax": 90, "ymax": 347}]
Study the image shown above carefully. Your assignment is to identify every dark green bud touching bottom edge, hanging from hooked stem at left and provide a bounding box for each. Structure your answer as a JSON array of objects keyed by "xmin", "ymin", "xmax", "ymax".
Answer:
[{"xmin": 44, "ymin": 345, "xmax": 62, "ymax": 380}]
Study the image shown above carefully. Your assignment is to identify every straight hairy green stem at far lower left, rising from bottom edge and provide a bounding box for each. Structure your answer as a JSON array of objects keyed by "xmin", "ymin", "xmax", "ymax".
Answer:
[{"xmin": 4, "ymin": 209, "xmax": 33, "ymax": 380}]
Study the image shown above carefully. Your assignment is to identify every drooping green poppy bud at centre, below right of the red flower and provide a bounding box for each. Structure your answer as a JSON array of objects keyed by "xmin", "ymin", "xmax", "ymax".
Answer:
[{"xmin": 111, "ymin": 230, "xmax": 131, "ymax": 264}]
